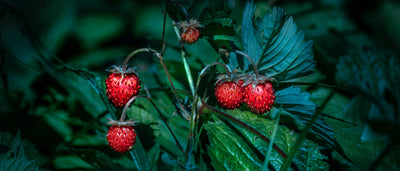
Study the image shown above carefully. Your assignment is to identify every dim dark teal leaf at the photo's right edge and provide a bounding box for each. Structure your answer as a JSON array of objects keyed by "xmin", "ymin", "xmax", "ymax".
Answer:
[{"xmin": 335, "ymin": 52, "xmax": 400, "ymax": 124}]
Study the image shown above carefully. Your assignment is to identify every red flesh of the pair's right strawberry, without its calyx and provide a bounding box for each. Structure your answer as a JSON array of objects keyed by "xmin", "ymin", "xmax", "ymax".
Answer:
[{"xmin": 244, "ymin": 82, "xmax": 275, "ymax": 114}]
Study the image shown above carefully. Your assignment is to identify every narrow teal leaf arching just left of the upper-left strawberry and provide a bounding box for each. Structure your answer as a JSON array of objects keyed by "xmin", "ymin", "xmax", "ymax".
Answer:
[{"xmin": 63, "ymin": 65, "xmax": 116, "ymax": 119}]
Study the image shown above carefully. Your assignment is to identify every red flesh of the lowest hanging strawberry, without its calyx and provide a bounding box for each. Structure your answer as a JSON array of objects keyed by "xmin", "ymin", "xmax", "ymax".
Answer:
[{"xmin": 107, "ymin": 126, "xmax": 136, "ymax": 153}]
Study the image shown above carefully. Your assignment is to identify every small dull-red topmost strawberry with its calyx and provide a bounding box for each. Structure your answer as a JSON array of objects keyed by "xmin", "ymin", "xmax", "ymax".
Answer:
[{"xmin": 177, "ymin": 19, "xmax": 203, "ymax": 44}]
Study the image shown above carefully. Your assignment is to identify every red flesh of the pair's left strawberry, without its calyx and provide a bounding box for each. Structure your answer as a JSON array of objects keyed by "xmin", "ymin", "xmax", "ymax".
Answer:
[{"xmin": 214, "ymin": 81, "xmax": 244, "ymax": 109}]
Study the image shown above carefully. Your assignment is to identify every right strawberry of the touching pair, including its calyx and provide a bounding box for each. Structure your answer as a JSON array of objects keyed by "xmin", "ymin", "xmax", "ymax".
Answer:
[{"xmin": 242, "ymin": 74, "xmax": 275, "ymax": 114}]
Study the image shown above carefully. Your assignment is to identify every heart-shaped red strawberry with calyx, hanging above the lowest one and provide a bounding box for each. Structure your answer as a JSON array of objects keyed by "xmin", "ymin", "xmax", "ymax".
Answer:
[{"xmin": 106, "ymin": 66, "xmax": 141, "ymax": 107}]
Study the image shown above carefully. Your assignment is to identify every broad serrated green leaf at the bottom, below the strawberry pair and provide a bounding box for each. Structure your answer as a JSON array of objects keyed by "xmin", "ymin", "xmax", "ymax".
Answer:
[{"xmin": 206, "ymin": 110, "xmax": 329, "ymax": 170}]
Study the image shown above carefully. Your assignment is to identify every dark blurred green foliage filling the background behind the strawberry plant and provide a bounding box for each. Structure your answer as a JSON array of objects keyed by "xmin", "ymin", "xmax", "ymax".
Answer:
[{"xmin": 0, "ymin": 0, "xmax": 400, "ymax": 170}]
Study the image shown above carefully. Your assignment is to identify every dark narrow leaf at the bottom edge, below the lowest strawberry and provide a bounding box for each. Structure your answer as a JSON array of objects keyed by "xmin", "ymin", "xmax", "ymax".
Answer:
[{"xmin": 62, "ymin": 147, "xmax": 124, "ymax": 170}]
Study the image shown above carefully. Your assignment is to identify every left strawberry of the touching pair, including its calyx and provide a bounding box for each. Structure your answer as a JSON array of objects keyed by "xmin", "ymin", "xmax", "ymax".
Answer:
[{"xmin": 214, "ymin": 74, "xmax": 244, "ymax": 109}]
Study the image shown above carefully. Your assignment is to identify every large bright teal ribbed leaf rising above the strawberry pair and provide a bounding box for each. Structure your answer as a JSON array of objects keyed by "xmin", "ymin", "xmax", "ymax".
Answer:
[{"xmin": 242, "ymin": 1, "xmax": 315, "ymax": 80}]
